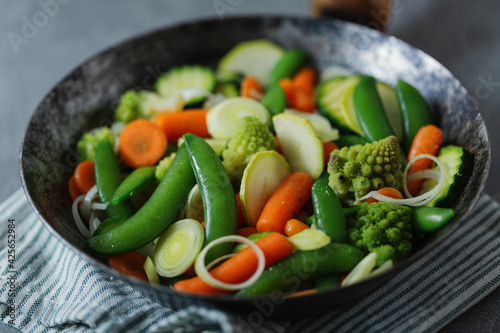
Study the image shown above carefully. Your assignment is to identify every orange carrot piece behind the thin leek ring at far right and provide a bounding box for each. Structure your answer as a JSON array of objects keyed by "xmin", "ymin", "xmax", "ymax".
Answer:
[{"xmin": 407, "ymin": 125, "xmax": 443, "ymax": 196}]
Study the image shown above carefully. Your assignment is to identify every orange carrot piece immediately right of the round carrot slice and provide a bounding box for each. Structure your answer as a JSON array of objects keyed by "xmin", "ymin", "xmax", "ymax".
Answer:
[{"xmin": 154, "ymin": 109, "xmax": 210, "ymax": 142}]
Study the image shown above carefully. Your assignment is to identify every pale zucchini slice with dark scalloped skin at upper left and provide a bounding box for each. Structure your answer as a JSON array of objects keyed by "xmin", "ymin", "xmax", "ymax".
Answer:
[{"xmin": 156, "ymin": 65, "xmax": 215, "ymax": 105}]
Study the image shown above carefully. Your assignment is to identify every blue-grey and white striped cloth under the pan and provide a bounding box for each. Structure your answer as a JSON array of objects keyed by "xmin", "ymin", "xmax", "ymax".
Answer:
[{"xmin": 0, "ymin": 190, "xmax": 500, "ymax": 333}]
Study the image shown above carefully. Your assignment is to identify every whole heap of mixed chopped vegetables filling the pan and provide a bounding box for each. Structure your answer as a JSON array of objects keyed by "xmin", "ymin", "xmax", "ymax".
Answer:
[{"xmin": 69, "ymin": 40, "xmax": 473, "ymax": 297}]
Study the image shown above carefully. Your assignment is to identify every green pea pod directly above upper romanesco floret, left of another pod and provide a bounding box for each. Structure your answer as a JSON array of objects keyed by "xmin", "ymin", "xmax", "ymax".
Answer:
[{"xmin": 353, "ymin": 76, "xmax": 394, "ymax": 142}]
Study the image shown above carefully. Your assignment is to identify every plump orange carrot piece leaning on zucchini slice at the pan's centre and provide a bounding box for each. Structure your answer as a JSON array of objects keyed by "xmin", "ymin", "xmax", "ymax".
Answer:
[{"xmin": 257, "ymin": 172, "xmax": 314, "ymax": 234}]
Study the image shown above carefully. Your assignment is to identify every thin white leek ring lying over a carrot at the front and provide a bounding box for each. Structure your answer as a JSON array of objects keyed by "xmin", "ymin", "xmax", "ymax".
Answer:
[{"xmin": 194, "ymin": 235, "xmax": 266, "ymax": 290}]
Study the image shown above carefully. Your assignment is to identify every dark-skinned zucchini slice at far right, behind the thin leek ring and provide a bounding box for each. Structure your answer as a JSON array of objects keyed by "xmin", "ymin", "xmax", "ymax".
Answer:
[{"xmin": 421, "ymin": 145, "xmax": 474, "ymax": 207}]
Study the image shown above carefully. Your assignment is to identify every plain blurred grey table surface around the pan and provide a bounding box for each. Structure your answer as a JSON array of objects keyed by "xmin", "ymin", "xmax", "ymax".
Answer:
[{"xmin": 0, "ymin": 0, "xmax": 500, "ymax": 332}]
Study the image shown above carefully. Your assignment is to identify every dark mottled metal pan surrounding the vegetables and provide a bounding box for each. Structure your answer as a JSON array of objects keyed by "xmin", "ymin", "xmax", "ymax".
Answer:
[{"xmin": 20, "ymin": 17, "xmax": 491, "ymax": 318}]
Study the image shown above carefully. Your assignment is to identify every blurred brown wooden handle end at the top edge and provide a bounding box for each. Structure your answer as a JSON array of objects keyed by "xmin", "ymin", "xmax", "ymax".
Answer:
[{"xmin": 311, "ymin": 0, "xmax": 391, "ymax": 31}]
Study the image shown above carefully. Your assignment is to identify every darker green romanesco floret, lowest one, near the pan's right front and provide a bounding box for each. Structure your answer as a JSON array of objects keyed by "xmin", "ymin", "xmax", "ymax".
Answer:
[{"xmin": 347, "ymin": 202, "xmax": 412, "ymax": 266}]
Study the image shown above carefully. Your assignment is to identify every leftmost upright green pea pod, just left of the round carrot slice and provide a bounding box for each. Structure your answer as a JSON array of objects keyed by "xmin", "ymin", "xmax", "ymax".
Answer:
[{"xmin": 95, "ymin": 140, "xmax": 135, "ymax": 220}]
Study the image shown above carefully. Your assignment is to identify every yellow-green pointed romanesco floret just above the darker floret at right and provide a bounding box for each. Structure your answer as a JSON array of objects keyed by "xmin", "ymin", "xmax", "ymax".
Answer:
[{"xmin": 328, "ymin": 136, "xmax": 403, "ymax": 205}]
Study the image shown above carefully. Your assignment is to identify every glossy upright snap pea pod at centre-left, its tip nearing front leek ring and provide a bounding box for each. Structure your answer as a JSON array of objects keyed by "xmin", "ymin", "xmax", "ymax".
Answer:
[{"xmin": 184, "ymin": 134, "xmax": 238, "ymax": 263}]
